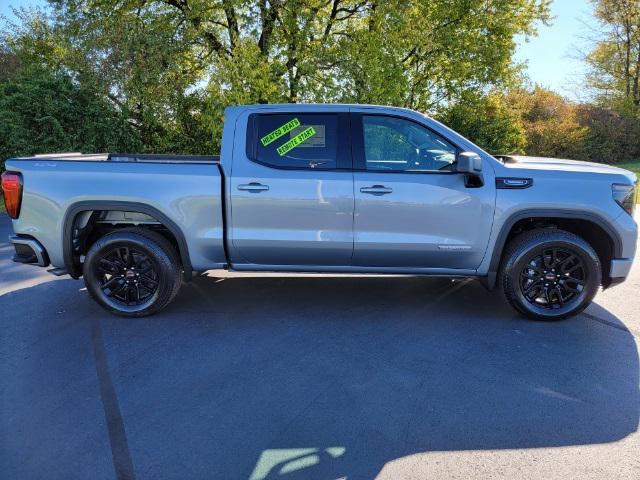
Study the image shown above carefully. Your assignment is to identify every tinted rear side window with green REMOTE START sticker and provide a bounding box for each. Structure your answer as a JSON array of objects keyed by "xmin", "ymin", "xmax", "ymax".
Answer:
[{"xmin": 247, "ymin": 114, "xmax": 338, "ymax": 170}]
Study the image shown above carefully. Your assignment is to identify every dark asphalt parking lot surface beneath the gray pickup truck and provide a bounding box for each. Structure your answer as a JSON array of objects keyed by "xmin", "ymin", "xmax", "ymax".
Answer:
[{"xmin": 0, "ymin": 214, "xmax": 640, "ymax": 480}]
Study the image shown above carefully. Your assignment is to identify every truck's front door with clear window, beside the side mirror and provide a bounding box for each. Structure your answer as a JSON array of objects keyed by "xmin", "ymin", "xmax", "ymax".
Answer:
[{"xmin": 352, "ymin": 114, "xmax": 495, "ymax": 270}]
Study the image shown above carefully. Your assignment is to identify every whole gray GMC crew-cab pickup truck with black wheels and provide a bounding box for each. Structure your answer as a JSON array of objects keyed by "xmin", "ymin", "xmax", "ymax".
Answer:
[{"xmin": 2, "ymin": 105, "xmax": 637, "ymax": 320}]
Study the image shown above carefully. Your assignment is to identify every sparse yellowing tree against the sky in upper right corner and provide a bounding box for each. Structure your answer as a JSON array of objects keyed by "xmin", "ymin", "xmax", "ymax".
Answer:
[{"xmin": 585, "ymin": 0, "xmax": 640, "ymax": 117}]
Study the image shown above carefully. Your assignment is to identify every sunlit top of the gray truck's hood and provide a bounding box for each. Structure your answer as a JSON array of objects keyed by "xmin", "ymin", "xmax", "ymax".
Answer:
[{"xmin": 496, "ymin": 155, "xmax": 637, "ymax": 183}]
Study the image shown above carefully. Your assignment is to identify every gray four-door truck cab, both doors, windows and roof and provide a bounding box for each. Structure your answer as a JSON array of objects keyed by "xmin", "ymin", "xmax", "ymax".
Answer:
[{"xmin": 222, "ymin": 105, "xmax": 495, "ymax": 274}]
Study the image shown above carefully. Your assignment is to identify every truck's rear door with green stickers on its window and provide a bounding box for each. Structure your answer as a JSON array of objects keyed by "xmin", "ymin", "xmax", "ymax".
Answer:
[{"xmin": 229, "ymin": 111, "xmax": 354, "ymax": 268}]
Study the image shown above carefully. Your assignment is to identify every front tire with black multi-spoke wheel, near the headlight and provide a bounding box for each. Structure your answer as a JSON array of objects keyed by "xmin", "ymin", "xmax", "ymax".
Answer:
[{"xmin": 500, "ymin": 228, "xmax": 602, "ymax": 321}]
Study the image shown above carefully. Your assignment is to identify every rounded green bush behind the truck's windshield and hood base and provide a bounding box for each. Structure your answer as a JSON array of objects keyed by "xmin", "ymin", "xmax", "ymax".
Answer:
[{"xmin": 438, "ymin": 91, "xmax": 527, "ymax": 154}]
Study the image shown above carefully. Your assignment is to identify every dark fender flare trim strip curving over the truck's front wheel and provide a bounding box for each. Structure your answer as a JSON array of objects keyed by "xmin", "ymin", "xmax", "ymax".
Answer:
[{"xmin": 486, "ymin": 208, "xmax": 622, "ymax": 289}]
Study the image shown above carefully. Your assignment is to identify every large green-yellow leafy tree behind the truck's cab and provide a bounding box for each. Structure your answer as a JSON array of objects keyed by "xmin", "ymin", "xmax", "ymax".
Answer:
[{"xmin": 1, "ymin": 0, "xmax": 549, "ymax": 153}]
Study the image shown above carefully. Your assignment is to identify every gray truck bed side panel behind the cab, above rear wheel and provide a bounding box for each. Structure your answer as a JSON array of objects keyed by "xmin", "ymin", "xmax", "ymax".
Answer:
[{"xmin": 6, "ymin": 153, "xmax": 226, "ymax": 273}]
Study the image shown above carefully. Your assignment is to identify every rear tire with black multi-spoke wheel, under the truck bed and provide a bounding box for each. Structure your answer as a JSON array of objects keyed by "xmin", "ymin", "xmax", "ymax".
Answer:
[{"xmin": 83, "ymin": 228, "xmax": 182, "ymax": 317}]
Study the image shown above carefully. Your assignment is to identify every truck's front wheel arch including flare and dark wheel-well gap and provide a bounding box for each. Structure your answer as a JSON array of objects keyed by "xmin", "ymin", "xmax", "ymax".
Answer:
[{"xmin": 487, "ymin": 209, "xmax": 622, "ymax": 289}]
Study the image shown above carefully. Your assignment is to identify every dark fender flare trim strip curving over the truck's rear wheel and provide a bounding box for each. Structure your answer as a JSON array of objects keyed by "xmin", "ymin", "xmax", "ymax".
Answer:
[{"xmin": 62, "ymin": 200, "xmax": 193, "ymax": 281}]
